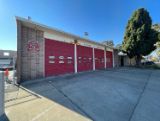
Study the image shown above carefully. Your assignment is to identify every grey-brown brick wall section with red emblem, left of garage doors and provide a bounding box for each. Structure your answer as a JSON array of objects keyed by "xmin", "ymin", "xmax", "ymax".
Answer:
[{"xmin": 17, "ymin": 26, "xmax": 44, "ymax": 81}]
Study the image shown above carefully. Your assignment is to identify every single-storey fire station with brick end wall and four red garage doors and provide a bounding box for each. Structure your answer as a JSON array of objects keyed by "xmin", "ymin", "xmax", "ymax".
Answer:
[{"xmin": 16, "ymin": 17, "xmax": 114, "ymax": 82}]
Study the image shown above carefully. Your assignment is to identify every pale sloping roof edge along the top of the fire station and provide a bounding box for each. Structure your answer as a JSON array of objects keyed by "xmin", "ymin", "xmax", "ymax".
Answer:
[{"xmin": 15, "ymin": 16, "xmax": 114, "ymax": 49}]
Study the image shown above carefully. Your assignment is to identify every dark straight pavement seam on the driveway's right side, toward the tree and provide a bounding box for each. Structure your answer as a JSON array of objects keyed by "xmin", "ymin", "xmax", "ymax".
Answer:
[{"xmin": 128, "ymin": 72, "xmax": 152, "ymax": 121}]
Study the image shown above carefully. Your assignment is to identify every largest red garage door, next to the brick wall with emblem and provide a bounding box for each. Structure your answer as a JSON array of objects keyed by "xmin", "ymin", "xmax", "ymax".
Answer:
[{"xmin": 45, "ymin": 39, "xmax": 74, "ymax": 76}]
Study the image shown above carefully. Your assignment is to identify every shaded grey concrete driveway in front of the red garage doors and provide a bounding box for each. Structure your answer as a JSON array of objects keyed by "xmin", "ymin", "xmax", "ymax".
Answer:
[{"xmin": 7, "ymin": 68, "xmax": 160, "ymax": 121}]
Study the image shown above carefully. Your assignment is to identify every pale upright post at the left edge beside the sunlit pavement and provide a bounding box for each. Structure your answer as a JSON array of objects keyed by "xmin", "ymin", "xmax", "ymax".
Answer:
[{"xmin": 0, "ymin": 72, "xmax": 4, "ymax": 116}]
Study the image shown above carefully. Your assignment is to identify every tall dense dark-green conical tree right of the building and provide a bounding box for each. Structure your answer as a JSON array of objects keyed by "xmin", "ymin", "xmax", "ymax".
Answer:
[{"xmin": 122, "ymin": 8, "xmax": 158, "ymax": 65}]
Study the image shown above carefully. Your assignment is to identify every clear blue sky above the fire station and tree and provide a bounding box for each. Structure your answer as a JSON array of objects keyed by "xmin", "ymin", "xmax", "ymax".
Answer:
[{"xmin": 0, "ymin": 0, "xmax": 160, "ymax": 50}]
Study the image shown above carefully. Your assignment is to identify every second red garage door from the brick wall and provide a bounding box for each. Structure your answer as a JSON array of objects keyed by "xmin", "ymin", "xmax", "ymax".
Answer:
[{"xmin": 77, "ymin": 45, "xmax": 93, "ymax": 72}]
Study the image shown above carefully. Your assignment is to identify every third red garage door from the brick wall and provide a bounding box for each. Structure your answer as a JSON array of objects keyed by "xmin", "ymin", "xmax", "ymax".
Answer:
[{"xmin": 94, "ymin": 49, "xmax": 104, "ymax": 69}]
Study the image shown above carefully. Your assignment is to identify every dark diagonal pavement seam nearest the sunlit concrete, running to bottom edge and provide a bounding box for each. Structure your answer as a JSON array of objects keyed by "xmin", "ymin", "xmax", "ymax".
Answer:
[{"xmin": 50, "ymin": 83, "xmax": 95, "ymax": 121}]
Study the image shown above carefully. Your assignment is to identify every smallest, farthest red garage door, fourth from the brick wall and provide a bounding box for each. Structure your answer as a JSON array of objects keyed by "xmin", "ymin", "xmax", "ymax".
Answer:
[{"xmin": 106, "ymin": 51, "xmax": 113, "ymax": 68}]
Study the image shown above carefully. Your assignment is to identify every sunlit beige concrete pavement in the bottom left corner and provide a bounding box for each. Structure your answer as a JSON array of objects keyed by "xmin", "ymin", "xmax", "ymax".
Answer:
[{"xmin": 5, "ymin": 88, "xmax": 90, "ymax": 121}]
